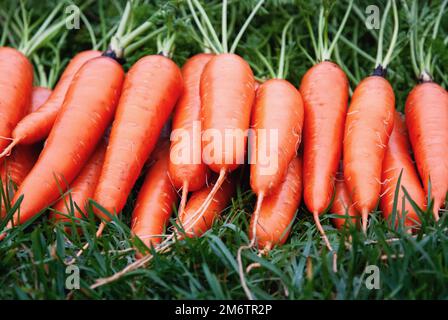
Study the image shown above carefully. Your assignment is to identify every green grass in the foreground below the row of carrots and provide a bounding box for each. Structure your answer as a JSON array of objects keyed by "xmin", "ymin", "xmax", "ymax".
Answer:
[{"xmin": 0, "ymin": 188, "xmax": 448, "ymax": 299}]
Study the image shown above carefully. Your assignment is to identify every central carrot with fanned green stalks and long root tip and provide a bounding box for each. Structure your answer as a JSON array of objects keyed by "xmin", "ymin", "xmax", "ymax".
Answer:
[{"xmin": 181, "ymin": 0, "xmax": 264, "ymax": 232}]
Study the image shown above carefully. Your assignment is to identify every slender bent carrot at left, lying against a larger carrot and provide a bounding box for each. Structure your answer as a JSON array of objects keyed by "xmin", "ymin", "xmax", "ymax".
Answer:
[{"xmin": 12, "ymin": 50, "xmax": 101, "ymax": 144}]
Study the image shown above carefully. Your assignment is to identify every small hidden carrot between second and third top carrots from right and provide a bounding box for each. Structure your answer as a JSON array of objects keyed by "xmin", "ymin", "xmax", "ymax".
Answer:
[{"xmin": 330, "ymin": 172, "xmax": 358, "ymax": 229}]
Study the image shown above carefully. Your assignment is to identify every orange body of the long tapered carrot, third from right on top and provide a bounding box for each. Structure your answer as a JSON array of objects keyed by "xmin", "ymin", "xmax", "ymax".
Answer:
[{"xmin": 300, "ymin": 61, "xmax": 348, "ymax": 214}]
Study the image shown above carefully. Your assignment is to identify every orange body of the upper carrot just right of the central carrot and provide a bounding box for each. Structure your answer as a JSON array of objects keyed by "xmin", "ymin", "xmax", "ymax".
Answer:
[{"xmin": 249, "ymin": 79, "xmax": 303, "ymax": 195}]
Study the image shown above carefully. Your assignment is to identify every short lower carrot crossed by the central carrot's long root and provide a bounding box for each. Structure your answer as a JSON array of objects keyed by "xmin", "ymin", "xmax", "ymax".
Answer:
[{"xmin": 179, "ymin": 177, "xmax": 235, "ymax": 238}]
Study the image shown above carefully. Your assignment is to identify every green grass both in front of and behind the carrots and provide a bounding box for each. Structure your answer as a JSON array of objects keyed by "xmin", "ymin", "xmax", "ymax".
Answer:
[{"xmin": 0, "ymin": 0, "xmax": 448, "ymax": 299}]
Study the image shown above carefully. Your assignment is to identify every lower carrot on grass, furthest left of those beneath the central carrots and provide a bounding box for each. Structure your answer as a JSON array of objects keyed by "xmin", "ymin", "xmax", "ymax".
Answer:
[{"xmin": 131, "ymin": 144, "xmax": 177, "ymax": 256}]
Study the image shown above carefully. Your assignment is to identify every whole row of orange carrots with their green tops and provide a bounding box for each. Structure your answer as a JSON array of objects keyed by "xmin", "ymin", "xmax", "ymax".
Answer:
[{"xmin": 0, "ymin": 0, "xmax": 448, "ymax": 298}]
